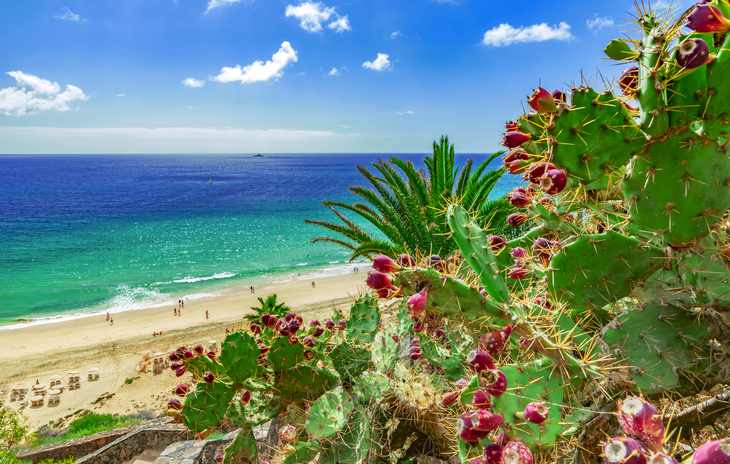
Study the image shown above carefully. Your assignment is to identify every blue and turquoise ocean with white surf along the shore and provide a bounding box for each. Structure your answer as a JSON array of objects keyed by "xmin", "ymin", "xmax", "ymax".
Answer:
[{"xmin": 0, "ymin": 154, "xmax": 513, "ymax": 329}]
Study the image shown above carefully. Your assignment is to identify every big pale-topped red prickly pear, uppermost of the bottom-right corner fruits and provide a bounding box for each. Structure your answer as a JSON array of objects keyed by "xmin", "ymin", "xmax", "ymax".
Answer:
[{"xmin": 617, "ymin": 396, "xmax": 664, "ymax": 452}]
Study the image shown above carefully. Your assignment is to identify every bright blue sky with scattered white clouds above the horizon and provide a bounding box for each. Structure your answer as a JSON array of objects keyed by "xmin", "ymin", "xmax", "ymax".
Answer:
[{"xmin": 0, "ymin": 0, "xmax": 693, "ymax": 154}]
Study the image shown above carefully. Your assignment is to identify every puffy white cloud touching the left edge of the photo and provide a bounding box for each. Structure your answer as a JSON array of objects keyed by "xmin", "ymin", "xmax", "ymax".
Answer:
[{"xmin": 0, "ymin": 71, "xmax": 88, "ymax": 116}]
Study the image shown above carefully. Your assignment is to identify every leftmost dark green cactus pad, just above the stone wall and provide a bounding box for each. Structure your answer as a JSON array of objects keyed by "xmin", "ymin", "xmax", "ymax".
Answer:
[{"xmin": 182, "ymin": 381, "xmax": 236, "ymax": 433}]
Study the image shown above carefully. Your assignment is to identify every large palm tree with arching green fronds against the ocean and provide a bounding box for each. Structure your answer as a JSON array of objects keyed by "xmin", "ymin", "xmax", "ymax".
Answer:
[{"xmin": 305, "ymin": 137, "xmax": 513, "ymax": 261}]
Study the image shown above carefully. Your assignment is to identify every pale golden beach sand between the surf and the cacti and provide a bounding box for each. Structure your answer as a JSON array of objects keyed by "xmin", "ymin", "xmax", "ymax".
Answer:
[{"xmin": 0, "ymin": 272, "xmax": 369, "ymax": 427}]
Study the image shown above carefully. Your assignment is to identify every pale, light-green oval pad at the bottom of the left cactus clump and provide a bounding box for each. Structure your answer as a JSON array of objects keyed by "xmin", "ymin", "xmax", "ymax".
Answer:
[{"xmin": 304, "ymin": 387, "xmax": 355, "ymax": 440}]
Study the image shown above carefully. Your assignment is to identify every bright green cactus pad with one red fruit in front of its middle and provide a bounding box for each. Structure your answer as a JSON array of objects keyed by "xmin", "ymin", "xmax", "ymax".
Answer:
[{"xmin": 494, "ymin": 359, "xmax": 567, "ymax": 449}]
